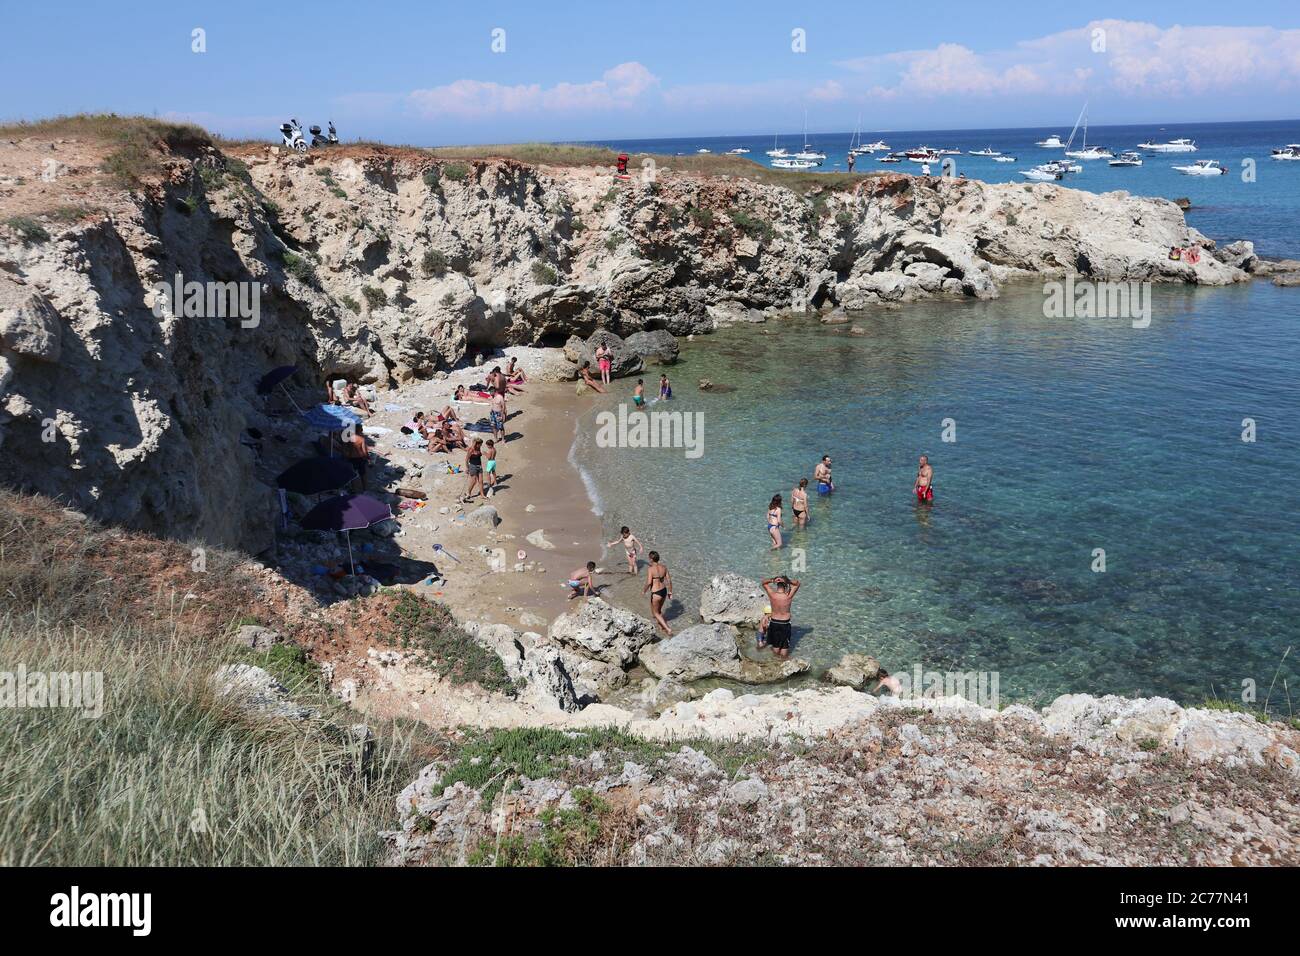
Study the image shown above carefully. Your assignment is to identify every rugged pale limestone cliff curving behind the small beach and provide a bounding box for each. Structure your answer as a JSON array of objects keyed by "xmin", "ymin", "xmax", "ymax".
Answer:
[{"xmin": 0, "ymin": 125, "xmax": 1253, "ymax": 550}]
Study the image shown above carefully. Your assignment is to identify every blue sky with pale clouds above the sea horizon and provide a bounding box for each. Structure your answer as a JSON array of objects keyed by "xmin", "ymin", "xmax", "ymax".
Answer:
[{"xmin": 0, "ymin": 0, "xmax": 1300, "ymax": 144}]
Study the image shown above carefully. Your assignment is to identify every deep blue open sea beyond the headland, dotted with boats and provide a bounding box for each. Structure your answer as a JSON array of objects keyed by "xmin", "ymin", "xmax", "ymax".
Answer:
[{"xmin": 590, "ymin": 116, "xmax": 1300, "ymax": 258}]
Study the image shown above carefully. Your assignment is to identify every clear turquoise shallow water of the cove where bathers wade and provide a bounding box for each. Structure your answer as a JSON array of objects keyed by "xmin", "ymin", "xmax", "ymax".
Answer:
[{"xmin": 575, "ymin": 282, "xmax": 1300, "ymax": 706}]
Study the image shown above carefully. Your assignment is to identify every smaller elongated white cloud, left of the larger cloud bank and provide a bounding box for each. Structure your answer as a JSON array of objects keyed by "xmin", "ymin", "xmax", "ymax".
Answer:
[{"xmin": 406, "ymin": 62, "xmax": 659, "ymax": 118}]
